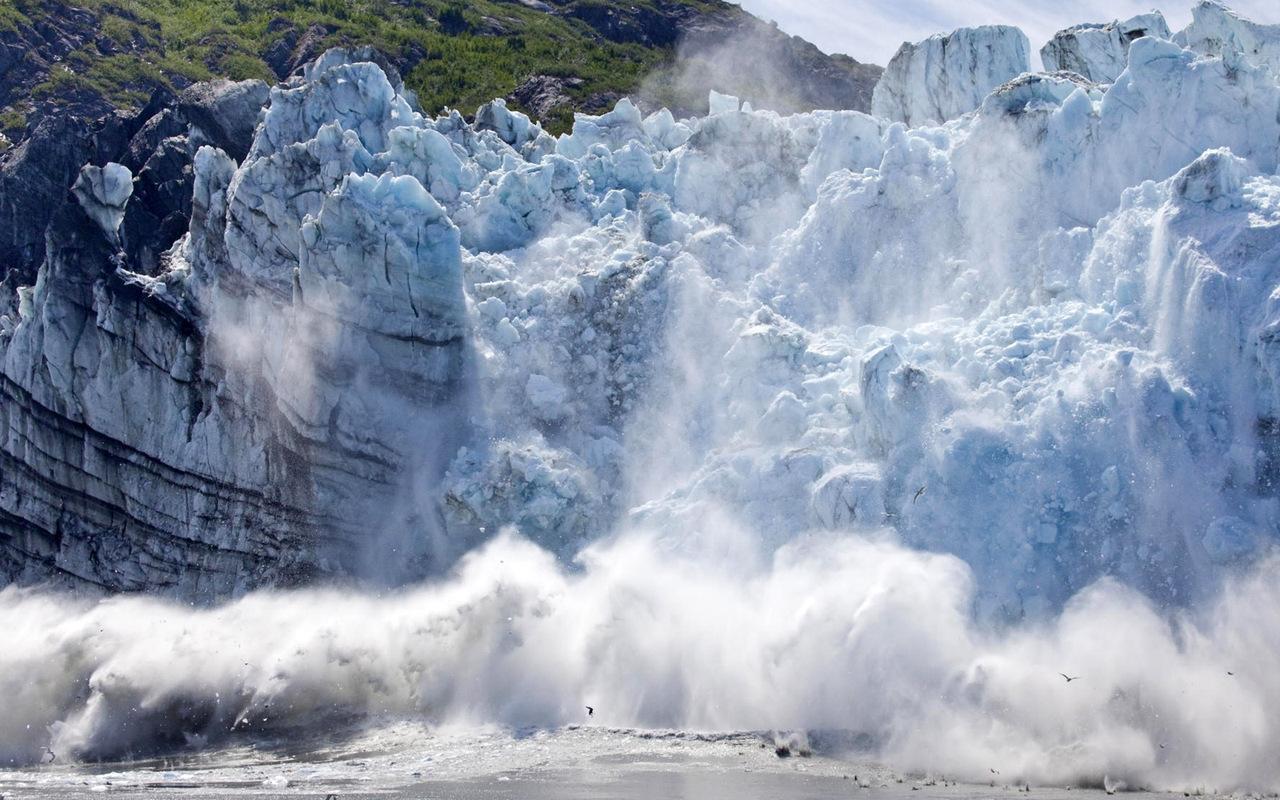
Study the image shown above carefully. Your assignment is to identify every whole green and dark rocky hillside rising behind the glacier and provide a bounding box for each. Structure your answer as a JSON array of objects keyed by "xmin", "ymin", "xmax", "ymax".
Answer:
[{"xmin": 0, "ymin": 0, "xmax": 879, "ymax": 141}]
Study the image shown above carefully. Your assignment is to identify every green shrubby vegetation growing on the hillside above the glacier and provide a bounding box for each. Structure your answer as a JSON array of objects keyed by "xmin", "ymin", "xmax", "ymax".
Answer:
[{"xmin": 10, "ymin": 0, "xmax": 742, "ymax": 128}]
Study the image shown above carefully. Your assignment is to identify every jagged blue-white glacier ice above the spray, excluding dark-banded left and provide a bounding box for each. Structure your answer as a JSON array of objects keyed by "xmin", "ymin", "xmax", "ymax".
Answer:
[{"xmin": 4, "ymin": 4, "xmax": 1280, "ymax": 616}]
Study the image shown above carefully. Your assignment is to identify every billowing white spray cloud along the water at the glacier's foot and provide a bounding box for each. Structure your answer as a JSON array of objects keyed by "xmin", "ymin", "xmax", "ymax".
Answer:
[{"xmin": 0, "ymin": 526, "xmax": 1280, "ymax": 790}]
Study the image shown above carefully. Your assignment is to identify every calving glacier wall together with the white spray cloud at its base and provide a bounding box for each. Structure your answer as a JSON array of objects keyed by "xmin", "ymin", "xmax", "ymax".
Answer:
[{"xmin": 0, "ymin": 3, "xmax": 1280, "ymax": 790}]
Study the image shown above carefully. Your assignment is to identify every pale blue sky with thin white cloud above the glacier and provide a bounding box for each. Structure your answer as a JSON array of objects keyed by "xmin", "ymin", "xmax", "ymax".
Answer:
[{"xmin": 739, "ymin": 0, "xmax": 1280, "ymax": 65}]
